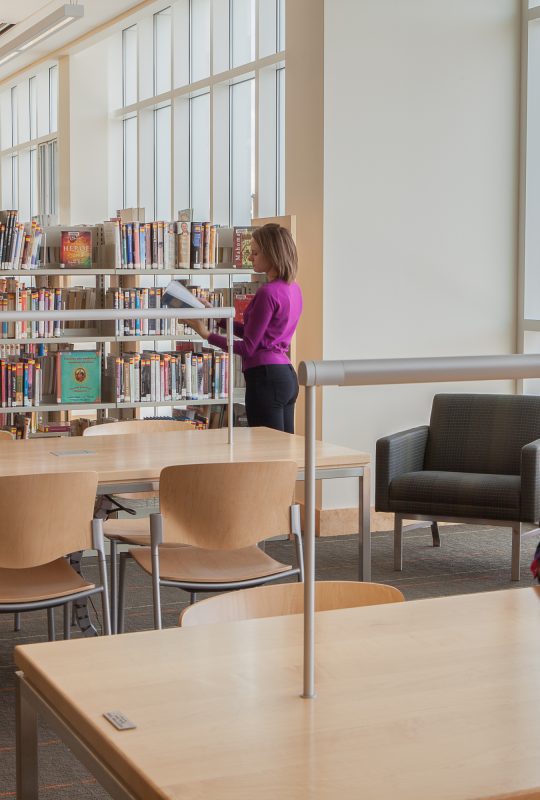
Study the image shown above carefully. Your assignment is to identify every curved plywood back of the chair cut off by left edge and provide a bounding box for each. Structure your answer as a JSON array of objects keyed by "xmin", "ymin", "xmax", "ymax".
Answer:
[{"xmin": 0, "ymin": 472, "xmax": 98, "ymax": 569}]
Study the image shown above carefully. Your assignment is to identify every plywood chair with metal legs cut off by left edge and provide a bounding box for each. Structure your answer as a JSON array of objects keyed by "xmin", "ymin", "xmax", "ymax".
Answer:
[{"xmin": 0, "ymin": 472, "xmax": 110, "ymax": 640}]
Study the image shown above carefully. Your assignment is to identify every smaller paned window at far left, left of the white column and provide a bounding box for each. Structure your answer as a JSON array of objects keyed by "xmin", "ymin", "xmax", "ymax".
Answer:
[{"xmin": 0, "ymin": 64, "xmax": 58, "ymax": 221}]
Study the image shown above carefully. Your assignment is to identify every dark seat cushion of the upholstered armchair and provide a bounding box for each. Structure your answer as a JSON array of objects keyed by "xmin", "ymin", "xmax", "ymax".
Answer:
[{"xmin": 388, "ymin": 470, "xmax": 521, "ymax": 520}]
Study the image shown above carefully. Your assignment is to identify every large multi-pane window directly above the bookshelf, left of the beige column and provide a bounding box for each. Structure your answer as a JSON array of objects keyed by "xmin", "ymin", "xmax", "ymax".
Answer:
[{"xmin": 116, "ymin": 0, "xmax": 285, "ymax": 225}]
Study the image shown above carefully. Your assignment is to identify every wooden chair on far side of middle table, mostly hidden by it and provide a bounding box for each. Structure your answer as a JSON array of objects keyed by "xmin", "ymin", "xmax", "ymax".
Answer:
[{"xmin": 83, "ymin": 419, "xmax": 193, "ymax": 633}]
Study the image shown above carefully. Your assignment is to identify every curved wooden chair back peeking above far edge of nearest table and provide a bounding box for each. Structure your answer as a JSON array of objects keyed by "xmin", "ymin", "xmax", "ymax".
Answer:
[{"xmin": 179, "ymin": 581, "xmax": 405, "ymax": 627}]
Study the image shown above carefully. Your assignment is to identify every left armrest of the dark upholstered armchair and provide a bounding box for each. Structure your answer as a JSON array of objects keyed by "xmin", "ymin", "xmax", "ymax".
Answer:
[{"xmin": 375, "ymin": 425, "xmax": 429, "ymax": 511}]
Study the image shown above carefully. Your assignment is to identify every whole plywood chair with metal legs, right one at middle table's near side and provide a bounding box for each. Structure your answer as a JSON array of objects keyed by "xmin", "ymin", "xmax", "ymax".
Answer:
[{"xmin": 118, "ymin": 461, "xmax": 303, "ymax": 631}]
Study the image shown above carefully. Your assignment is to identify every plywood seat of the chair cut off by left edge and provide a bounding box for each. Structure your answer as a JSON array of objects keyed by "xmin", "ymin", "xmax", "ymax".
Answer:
[{"xmin": 0, "ymin": 558, "xmax": 95, "ymax": 605}]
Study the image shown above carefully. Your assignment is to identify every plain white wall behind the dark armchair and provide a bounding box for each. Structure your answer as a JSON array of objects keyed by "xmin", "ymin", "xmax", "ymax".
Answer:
[{"xmin": 323, "ymin": 0, "xmax": 519, "ymax": 507}]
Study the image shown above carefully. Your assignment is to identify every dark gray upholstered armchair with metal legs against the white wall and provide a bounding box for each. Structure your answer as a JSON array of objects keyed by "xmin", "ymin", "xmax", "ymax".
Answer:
[{"xmin": 375, "ymin": 394, "xmax": 540, "ymax": 581}]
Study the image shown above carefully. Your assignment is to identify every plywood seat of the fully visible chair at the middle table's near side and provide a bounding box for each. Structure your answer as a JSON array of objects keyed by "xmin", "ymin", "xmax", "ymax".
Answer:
[{"xmin": 130, "ymin": 546, "xmax": 292, "ymax": 584}]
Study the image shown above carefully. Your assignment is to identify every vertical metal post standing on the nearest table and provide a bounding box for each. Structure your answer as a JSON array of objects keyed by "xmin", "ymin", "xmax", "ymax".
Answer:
[{"xmin": 302, "ymin": 386, "xmax": 316, "ymax": 699}]
